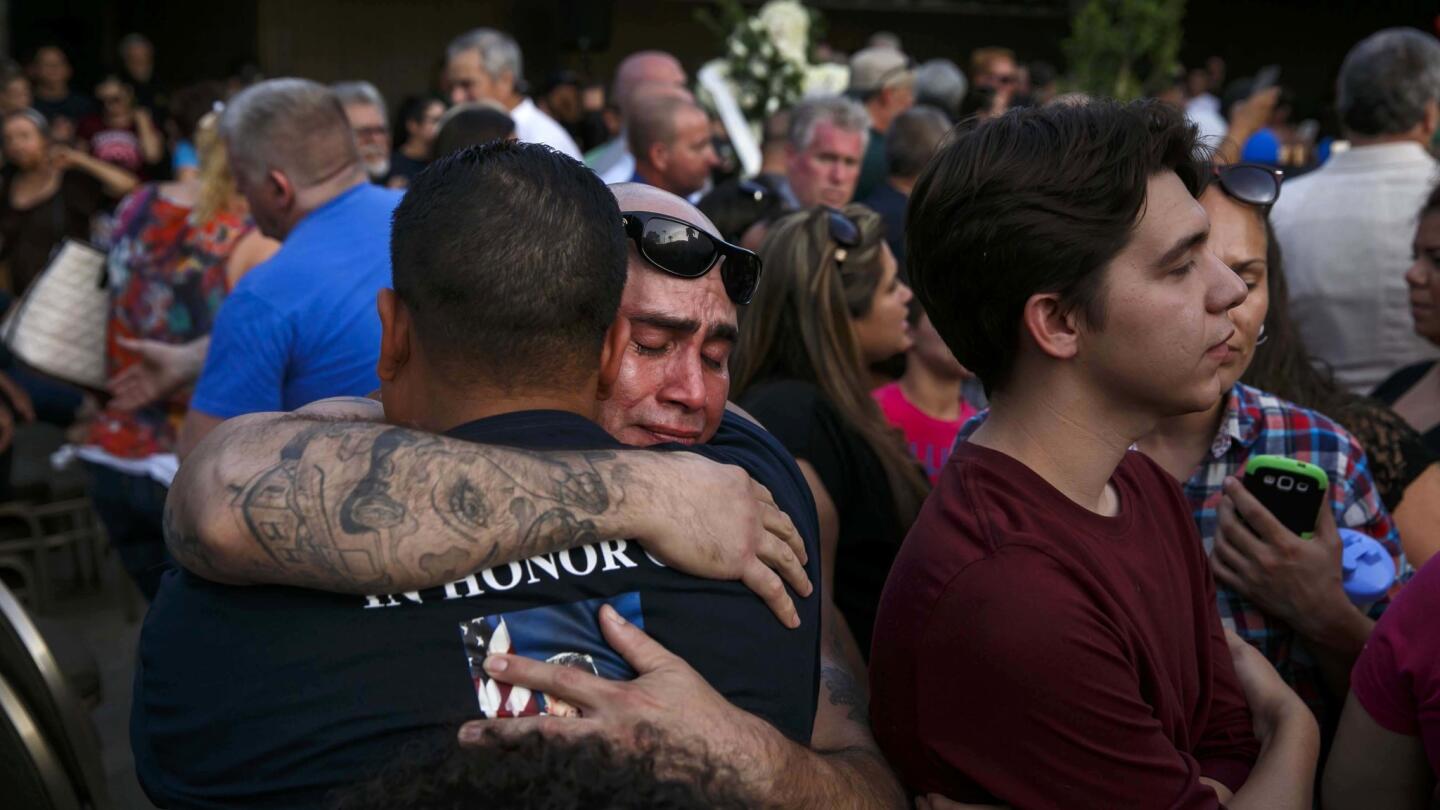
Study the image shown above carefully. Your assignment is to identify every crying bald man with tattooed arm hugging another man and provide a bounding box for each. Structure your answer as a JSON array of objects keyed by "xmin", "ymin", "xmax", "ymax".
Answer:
[{"xmin": 167, "ymin": 176, "xmax": 903, "ymax": 807}]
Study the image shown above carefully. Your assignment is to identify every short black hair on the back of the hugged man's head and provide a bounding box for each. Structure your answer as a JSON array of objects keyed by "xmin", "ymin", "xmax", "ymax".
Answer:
[{"xmin": 390, "ymin": 141, "xmax": 626, "ymax": 391}]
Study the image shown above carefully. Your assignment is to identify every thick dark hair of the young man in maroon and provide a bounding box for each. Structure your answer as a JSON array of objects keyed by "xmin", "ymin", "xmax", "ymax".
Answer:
[{"xmin": 906, "ymin": 101, "xmax": 1205, "ymax": 391}]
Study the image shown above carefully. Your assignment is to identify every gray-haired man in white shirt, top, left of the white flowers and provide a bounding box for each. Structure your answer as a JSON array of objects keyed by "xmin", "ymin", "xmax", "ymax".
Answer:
[{"xmin": 445, "ymin": 29, "xmax": 580, "ymax": 160}]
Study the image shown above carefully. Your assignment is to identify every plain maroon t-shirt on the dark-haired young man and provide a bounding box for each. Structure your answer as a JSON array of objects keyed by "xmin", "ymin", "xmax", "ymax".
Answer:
[{"xmin": 870, "ymin": 442, "xmax": 1260, "ymax": 809}]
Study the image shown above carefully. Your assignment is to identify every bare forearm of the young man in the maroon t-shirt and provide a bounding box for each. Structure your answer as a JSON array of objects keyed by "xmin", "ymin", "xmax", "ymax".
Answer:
[{"xmin": 1225, "ymin": 696, "xmax": 1320, "ymax": 810}]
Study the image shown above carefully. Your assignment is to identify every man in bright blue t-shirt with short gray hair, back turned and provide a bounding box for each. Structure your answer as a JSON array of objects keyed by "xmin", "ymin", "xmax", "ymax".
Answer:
[{"xmin": 180, "ymin": 79, "xmax": 400, "ymax": 458}]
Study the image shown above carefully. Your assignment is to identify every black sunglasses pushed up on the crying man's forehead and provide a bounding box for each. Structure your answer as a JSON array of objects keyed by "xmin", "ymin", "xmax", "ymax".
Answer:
[{"xmin": 621, "ymin": 210, "xmax": 760, "ymax": 307}]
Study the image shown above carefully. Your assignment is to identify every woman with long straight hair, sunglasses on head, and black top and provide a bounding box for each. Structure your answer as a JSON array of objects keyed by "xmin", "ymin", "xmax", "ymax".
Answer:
[{"xmin": 730, "ymin": 205, "xmax": 930, "ymax": 654}]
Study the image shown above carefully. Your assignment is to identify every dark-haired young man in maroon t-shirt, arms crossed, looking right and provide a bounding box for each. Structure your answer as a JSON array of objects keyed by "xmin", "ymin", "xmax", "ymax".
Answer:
[{"xmin": 870, "ymin": 102, "xmax": 1318, "ymax": 809}]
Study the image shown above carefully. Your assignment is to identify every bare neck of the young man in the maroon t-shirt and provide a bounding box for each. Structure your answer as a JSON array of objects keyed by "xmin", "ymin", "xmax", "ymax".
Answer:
[{"xmin": 971, "ymin": 368, "xmax": 1155, "ymax": 515}]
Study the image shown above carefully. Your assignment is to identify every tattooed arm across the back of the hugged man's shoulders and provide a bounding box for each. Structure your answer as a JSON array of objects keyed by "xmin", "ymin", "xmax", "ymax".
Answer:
[{"xmin": 164, "ymin": 399, "xmax": 811, "ymax": 624}]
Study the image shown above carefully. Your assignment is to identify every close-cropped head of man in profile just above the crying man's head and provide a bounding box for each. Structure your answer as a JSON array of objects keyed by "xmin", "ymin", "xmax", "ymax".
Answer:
[{"xmin": 625, "ymin": 98, "xmax": 720, "ymax": 197}]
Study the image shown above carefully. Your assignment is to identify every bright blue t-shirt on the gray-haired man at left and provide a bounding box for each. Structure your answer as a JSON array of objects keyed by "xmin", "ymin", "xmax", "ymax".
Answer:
[{"xmin": 190, "ymin": 183, "xmax": 403, "ymax": 419}]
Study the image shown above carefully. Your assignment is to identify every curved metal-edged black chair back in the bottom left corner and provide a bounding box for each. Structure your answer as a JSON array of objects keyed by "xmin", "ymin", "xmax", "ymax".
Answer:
[{"xmin": 0, "ymin": 584, "xmax": 114, "ymax": 810}]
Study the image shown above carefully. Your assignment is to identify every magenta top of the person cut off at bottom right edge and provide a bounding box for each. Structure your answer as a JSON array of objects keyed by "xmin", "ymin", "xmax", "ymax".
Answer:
[{"xmin": 1351, "ymin": 556, "xmax": 1440, "ymax": 775}]
